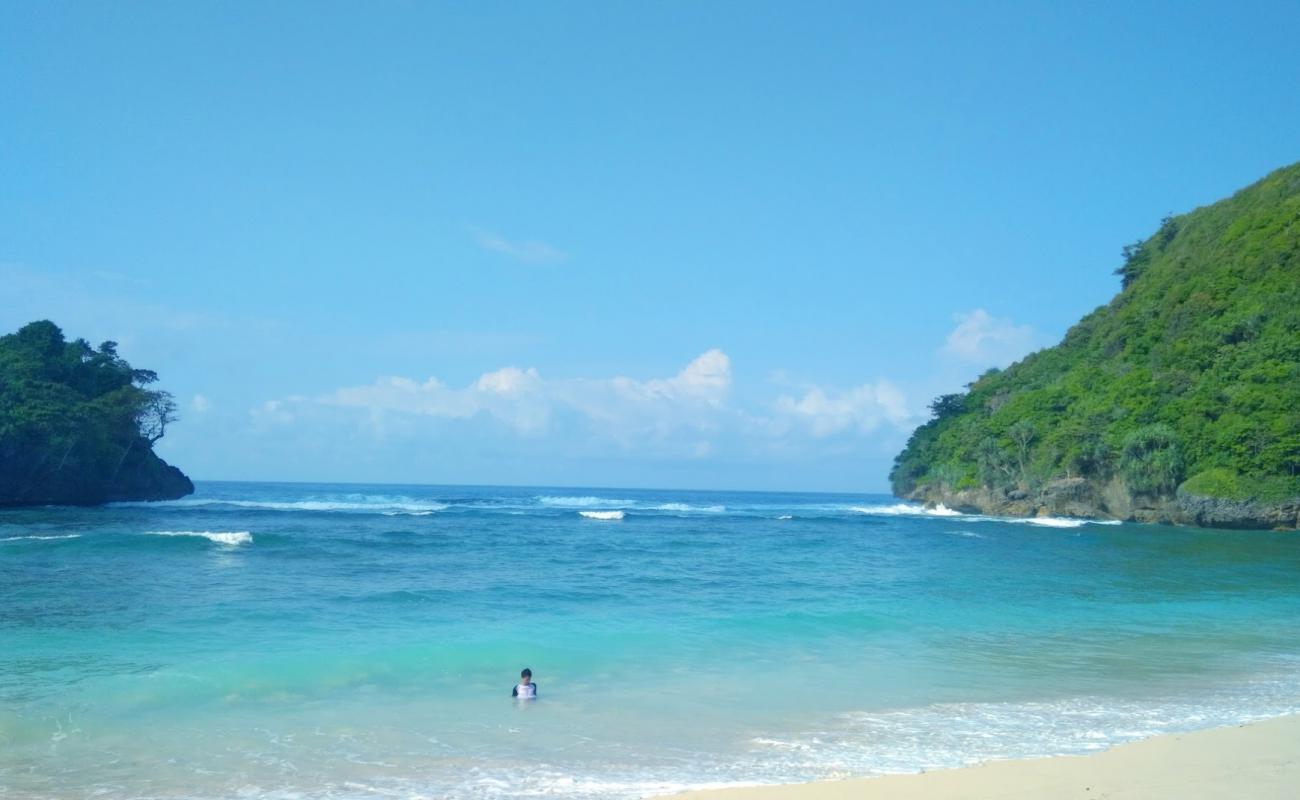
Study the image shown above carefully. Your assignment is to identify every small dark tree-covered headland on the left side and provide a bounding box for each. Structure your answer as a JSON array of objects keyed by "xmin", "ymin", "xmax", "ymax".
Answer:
[{"xmin": 0, "ymin": 321, "xmax": 194, "ymax": 505}]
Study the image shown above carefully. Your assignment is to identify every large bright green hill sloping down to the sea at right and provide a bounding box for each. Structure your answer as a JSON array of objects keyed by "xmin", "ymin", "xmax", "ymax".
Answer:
[{"xmin": 891, "ymin": 164, "xmax": 1300, "ymax": 527}]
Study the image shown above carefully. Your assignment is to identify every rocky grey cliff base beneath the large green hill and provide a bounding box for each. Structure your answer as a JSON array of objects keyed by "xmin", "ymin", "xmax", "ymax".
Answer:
[{"xmin": 905, "ymin": 477, "xmax": 1300, "ymax": 531}]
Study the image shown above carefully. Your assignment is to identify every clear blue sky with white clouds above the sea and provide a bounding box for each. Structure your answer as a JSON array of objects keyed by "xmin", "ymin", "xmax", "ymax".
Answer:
[{"xmin": 0, "ymin": 1, "xmax": 1300, "ymax": 492}]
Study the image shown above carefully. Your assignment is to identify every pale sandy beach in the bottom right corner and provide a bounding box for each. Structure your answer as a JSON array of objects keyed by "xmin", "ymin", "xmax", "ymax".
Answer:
[{"xmin": 679, "ymin": 715, "xmax": 1300, "ymax": 800}]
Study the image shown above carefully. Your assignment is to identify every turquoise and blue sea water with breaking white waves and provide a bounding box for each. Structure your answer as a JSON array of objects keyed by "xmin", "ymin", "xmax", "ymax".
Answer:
[{"xmin": 0, "ymin": 483, "xmax": 1300, "ymax": 799}]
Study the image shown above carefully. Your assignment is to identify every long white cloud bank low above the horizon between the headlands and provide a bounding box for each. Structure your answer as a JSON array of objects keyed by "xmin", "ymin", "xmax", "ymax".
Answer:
[{"xmin": 254, "ymin": 349, "xmax": 918, "ymax": 460}]
